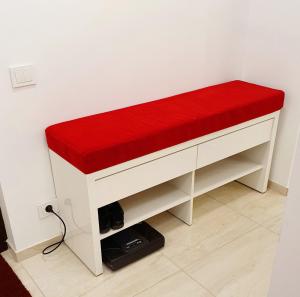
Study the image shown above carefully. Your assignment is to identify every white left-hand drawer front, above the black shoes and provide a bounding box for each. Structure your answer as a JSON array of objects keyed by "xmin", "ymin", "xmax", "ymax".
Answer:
[{"xmin": 89, "ymin": 146, "xmax": 197, "ymax": 207}]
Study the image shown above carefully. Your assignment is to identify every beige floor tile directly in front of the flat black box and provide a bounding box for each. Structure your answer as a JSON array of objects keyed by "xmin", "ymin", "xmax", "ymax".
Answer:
[{"xmin": 84, "ymin": 252, "xmax": 179, "ymax": 297}]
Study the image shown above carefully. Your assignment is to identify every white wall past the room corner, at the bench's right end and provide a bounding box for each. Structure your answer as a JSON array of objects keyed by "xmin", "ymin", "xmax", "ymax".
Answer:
[{"xmin": 242, "ymin": 0, "xmax": 300, "ymax": 187}]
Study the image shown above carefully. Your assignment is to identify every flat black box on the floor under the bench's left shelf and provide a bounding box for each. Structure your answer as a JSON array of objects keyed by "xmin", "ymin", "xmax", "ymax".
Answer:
[{"xmin": 101, "ymin": 222, "xmax": 165, "ymax": 270}]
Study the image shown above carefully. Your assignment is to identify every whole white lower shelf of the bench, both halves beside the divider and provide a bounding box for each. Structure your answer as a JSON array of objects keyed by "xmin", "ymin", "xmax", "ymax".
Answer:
[{"xmin": 100, "ymin": 155, "xmax": 262, "ymax": 239}]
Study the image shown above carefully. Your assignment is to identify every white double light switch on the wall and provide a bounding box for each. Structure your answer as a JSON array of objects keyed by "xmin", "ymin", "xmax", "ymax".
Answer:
[{"xmin": 9, "ymin": 65, "xmax": 36, "ymax": 88}]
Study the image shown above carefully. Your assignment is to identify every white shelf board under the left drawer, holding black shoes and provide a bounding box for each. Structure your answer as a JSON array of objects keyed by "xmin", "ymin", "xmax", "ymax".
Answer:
[{"xmin": 100, "ymin": 182, "xmax": 191, "ymax": 239}]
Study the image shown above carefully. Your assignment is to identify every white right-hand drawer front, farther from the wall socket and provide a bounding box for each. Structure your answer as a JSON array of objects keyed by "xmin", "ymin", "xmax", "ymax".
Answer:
[{"xmin": 197, "ymin": 119, "xmax": 273, "ymax": 168}]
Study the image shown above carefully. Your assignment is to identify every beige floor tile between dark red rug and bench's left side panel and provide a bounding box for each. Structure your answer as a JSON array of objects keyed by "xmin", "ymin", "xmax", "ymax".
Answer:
[{"xmin": 22, "ymin": 245, "xmax": 112, "ymax": 297}]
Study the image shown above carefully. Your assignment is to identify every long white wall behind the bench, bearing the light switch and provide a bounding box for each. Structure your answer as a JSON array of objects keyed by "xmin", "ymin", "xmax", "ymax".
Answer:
[{"xmin": 0, "ymin": 0, "xmax": 246, "ymax": 250}]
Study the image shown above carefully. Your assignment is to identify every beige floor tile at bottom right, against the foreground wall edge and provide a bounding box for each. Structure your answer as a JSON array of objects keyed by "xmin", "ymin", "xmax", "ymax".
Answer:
[{"xmin": 185, "ymin": 227, "xmax": 278, "ymax": 297}]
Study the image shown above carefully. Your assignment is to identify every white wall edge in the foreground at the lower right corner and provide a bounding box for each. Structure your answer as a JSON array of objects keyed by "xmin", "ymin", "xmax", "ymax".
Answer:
[{"xmin": 269, "ymin": 132, "xmax": 300, "ymax": 297}]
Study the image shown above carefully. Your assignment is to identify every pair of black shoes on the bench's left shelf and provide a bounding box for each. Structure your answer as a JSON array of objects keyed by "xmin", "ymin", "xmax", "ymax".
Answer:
[{"xmin": 98, "ymin": 202, "xmax": 124, "ymax": 234}]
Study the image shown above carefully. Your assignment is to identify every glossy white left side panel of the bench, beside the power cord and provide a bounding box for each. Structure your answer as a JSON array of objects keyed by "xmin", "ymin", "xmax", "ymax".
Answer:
[{"xmin": 50, "ymin": 152, "xmax": 103, "ymax": 275}]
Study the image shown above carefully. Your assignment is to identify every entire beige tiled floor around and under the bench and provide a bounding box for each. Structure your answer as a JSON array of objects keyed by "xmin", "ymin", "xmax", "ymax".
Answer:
[{"xmin": 3, "ymin": 183, "xmax": 286, "ymax": 297}]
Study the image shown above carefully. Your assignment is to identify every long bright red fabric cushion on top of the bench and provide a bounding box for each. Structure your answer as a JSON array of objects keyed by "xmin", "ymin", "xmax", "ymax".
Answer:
[{"xmin": 46, "ymin": 81, "xmax": 284, "ymax": 174}]
